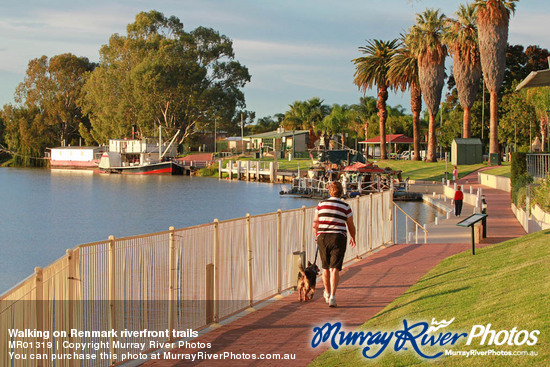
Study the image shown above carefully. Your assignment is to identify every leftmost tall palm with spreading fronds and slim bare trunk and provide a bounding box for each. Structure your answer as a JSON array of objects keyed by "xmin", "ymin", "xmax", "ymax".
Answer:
[{"xmin": 353, "ymin": 40, "xmax": 398, "ymax": 159}]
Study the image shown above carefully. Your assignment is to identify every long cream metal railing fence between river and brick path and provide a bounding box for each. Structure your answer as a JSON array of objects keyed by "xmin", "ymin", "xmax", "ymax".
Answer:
[{"xmin": 0, "ymin": 191, "xmax": 393, "ymax": 367}]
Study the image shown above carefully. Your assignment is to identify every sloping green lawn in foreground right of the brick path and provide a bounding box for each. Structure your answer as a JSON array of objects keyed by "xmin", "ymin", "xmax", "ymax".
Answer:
[{"xmin": 311, "ymin": 230, "xmax": 550, "ymax": 367}]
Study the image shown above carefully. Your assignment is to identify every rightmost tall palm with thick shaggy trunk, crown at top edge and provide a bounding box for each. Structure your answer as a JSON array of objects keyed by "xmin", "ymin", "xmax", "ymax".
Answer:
[{"xmin": 475, "ymin": 0, "xmax": 517, "ymax": 153}]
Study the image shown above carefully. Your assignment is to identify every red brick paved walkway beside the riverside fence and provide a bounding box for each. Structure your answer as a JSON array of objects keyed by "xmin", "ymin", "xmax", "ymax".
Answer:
[{"xmin": 141, "ymin": 168, "xmax": 525, "ymax": 367}]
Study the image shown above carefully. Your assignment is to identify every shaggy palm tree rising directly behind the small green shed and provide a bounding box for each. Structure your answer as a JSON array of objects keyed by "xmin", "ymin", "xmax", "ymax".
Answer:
[{"xmin": 444, "ymin": 4, "xmax": 481, "ymax": 138}]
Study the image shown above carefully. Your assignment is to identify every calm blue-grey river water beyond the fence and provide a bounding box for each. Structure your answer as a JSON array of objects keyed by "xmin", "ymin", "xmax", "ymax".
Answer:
[{"xmin": 0, "ymin": 168, "xmax": 442, "ymax": 294}]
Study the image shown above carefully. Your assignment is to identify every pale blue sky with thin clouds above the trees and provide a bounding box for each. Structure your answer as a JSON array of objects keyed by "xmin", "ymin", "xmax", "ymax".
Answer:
[{"xmin": 0, "ymin": 0, "xmax": 550, "ymax": 118}]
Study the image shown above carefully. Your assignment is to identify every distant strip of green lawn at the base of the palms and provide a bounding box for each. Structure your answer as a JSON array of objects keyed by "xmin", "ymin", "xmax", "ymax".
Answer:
[{"xmin": 376, "ymin": 160, "xmax": 487, "ymax": 181}]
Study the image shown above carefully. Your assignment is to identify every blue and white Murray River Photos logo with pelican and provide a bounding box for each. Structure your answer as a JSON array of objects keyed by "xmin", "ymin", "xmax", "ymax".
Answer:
[{"xmin": 311, "ymin": 318, "xmax": 540, "ymax": 359}]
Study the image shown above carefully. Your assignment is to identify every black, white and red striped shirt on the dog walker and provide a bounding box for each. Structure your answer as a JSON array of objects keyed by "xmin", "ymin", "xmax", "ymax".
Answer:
[{"xmin": 315, "ymin": 197, "xmax": 352, "ymax": 236}]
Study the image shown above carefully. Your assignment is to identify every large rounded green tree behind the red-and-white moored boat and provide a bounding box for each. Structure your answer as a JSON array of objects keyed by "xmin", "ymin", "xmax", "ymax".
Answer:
[{"xmin": 82, "ymin": 11, "xmax": 250, "ymax": 143}]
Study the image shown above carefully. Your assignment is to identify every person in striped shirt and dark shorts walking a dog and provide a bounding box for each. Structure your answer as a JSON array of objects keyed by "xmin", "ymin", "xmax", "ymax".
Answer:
[{"xmin": 313, "ymin": 181, "xmax": 355, "ymax": 307}]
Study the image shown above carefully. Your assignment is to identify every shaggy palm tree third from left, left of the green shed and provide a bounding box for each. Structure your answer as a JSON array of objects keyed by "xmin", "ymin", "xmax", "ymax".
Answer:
[{"xmin": 406, "ymin": 9, "xmax": 447, "ymax": 162}]
